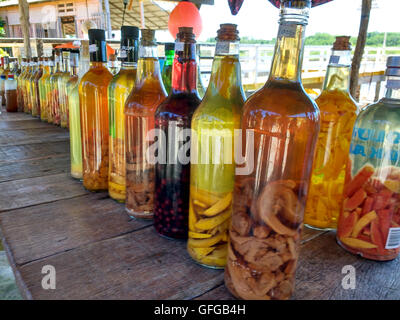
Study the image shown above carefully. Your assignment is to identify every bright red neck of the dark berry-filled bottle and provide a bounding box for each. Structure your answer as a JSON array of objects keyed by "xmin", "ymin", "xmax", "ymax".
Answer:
[{"xmin": 171, "ymin": 42, "xmax": 197, "ymax": 94}]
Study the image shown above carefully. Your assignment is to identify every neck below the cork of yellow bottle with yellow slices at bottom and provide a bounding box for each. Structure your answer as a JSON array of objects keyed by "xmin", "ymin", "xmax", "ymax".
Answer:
[{"xmin": 207, "ymin": 41, "xmax": 244, "ymax": 99}]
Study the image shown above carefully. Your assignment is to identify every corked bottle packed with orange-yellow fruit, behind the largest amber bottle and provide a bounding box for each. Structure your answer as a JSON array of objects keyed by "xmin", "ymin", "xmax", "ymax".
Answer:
[{"xmin": 304, "ymin": 37, "xmax": 358, "ymax": 229}]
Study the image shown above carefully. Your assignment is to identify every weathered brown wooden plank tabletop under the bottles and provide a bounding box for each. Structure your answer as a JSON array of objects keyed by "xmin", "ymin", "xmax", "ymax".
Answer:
[{"xmin": 0, "ymin": 110, "xmax": 400, "ymax": 299}]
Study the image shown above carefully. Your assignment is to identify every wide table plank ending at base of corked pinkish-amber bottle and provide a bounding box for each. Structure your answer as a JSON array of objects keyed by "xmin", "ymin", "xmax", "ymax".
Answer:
[{"xmin": 0, "ymin": 193, "xmax": 152, "ymax": 265}]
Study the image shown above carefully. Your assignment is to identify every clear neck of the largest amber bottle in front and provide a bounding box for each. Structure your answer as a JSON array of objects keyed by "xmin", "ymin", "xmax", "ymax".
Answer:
[{"xmin": 269, "ymin": 13, "xmax": 307, "ymax": 82}]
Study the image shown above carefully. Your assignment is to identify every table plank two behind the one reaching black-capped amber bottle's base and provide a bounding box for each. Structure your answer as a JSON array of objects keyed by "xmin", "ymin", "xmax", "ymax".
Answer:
[{"xmin": 0, "ymin": 141, "xmax": 69, "ymax": 164}]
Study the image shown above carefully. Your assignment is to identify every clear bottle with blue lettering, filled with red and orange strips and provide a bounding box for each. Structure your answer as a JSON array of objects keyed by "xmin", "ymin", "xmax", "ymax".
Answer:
[{"xmin": 336, "ymin": 56, "xmax": 400, "ymax": 261}]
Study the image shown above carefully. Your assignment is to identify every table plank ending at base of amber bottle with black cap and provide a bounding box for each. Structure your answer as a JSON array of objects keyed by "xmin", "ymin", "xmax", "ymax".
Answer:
[{"xmin": 0, "ymin": 173, "xmax": 88, "ymax": 212}]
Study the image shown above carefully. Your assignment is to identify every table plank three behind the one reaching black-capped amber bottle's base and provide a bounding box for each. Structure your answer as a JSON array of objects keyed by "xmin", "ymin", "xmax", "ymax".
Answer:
[{"xmin": 0, "ymin": 125, "xmax": 69, "ymax": 146}]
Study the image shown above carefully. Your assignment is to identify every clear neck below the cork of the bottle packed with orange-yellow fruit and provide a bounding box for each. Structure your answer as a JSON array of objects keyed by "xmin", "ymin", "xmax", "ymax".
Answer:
[{"xmin": 322, "ymin": 50, "xmax": 351, "ymax": 91}]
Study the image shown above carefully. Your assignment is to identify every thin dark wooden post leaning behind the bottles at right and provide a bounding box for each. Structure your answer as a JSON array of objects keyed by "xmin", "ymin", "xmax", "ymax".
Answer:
[{"xmin": 350, "ymin": 0, "xmax": 372, "ymax": 101}]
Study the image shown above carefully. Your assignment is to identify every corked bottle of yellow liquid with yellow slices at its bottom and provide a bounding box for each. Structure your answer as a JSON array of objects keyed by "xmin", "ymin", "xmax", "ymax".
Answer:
[{"xmin": 188, "ymin": 24, "xmax": 245, "ymax": 268}]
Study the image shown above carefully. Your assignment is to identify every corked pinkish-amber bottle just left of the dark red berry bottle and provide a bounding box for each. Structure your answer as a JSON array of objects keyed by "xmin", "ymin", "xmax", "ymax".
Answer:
[{"xmin": 125, "ymin": 29, "xmax": 167, "ymax": 219}]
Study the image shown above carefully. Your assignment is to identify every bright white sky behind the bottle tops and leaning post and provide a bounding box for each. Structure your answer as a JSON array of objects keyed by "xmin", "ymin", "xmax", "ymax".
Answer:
[{"xmin": 157, "ymin": 0, "xmax": 400, "ymax": 41}]
